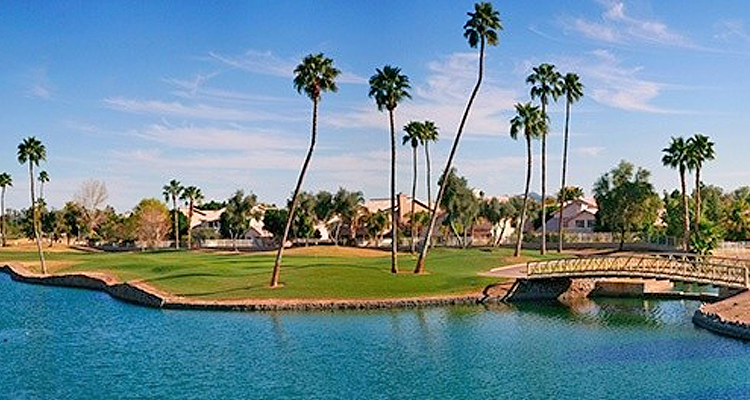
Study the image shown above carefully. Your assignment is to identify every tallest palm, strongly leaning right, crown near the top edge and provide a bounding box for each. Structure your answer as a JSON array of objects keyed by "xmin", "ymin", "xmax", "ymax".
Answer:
[{"xmin": 414, "ymin": 3, "xmax": 503, "ymax": 274}]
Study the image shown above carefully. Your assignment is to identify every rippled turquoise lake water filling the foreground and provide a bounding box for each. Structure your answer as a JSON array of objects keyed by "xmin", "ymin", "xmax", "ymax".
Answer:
[{"xmin": 0, "ymin": 274, "xmax": 750, "ymax": 399}]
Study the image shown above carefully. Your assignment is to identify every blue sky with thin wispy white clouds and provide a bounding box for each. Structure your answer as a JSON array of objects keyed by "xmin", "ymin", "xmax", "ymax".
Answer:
[{"xmin": 0, "ymin": 0, "xmax": 750, "ymax": 211}]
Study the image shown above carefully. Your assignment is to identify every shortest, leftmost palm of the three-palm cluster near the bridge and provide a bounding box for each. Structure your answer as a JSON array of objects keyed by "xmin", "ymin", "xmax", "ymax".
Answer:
[{"xmin": 510, "ymin": 103, "xmax": 547, "ymax": 257}]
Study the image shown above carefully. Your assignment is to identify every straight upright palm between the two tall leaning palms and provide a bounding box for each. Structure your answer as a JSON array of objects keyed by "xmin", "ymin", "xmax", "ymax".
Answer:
[{"xmin": 368, "ymin": 65, "xmax": 411, "ymax": 274}]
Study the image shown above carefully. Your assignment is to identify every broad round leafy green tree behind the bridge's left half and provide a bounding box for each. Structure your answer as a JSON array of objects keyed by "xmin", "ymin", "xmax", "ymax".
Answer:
[{"xmin": 594, "ymin": 160, "xmax": 661, "ymax": 250}]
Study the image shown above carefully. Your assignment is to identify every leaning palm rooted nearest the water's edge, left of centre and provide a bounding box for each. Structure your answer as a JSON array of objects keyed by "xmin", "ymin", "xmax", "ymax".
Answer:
[{"xmin": 271, "ymin": 53, "xmax": 341, "ymax": 287}]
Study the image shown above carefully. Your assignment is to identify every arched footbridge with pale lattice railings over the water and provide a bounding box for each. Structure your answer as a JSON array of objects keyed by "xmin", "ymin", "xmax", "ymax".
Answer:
[{"xmin": 526, "ymin": 254, "xmax": 750, "ymax": 289}]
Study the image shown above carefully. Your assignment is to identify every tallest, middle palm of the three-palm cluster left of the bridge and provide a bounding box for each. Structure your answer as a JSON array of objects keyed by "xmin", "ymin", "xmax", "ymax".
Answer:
[{"xmin": 526, "ymin": 63, "xmax": 562, "ymax": 254}]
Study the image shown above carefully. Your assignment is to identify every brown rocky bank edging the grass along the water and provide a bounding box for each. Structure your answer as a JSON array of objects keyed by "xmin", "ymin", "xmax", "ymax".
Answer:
[{"xmin": 0, "ymin": 264, "xmax": 511, "ymax": 311}]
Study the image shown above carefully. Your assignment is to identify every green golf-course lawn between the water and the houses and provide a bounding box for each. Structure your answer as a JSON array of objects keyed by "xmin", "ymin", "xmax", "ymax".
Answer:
[{"xmin": 0, "ymin": 246, "xmax": 559, "ymax": 300}]
